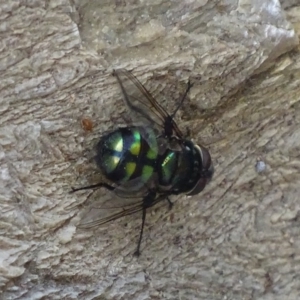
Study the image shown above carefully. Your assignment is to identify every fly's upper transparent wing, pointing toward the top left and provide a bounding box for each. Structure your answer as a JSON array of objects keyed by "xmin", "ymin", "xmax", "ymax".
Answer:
[{"xmin": 113, "ymin": 69, "xmax": 183, "ymax": 138}]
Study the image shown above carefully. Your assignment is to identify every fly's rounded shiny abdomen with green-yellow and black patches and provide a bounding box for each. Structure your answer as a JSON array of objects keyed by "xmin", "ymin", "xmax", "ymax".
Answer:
[{"xmin": 96, "ymin": 127, "xmax": 158, "ymax": 185}]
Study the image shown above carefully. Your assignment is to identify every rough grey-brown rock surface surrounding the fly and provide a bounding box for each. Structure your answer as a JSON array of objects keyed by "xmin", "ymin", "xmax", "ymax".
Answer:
[{"xmin": 0, "ymin": 0, "xmax": 300, "ymax": 300}]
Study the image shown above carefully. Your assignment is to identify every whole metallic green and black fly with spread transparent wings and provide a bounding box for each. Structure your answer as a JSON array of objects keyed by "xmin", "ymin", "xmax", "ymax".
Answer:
[{"xmin": 71, "ymin": 69, "xmax": 214, "ymax": 255}]
